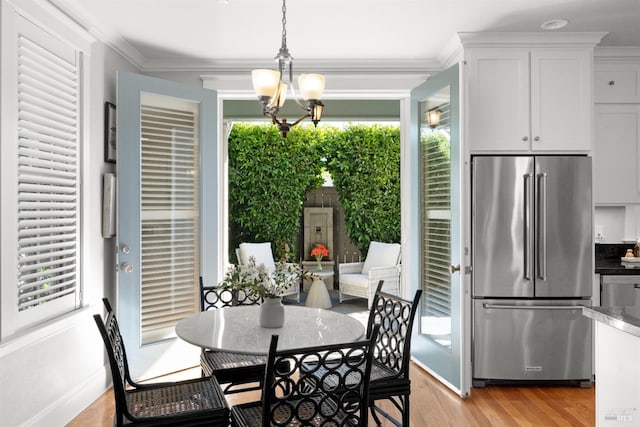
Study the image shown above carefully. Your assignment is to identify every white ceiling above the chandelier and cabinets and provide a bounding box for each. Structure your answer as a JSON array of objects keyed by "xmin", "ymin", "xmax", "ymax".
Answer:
[{"xmin": 48, "ymin": 0, "xmax": 640, "ymax": 72}]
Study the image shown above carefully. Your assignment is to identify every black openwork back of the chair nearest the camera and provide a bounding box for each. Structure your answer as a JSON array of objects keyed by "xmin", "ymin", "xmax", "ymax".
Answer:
[{"xmin": 262, "ymin": 327, "xmax": 378, "ymax": 427}]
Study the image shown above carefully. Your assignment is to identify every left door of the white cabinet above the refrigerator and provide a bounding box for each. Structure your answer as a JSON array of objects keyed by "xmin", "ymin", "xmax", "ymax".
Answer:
[{"xmin": 467, "ymin": 48, "xmax": 530, "ymax": 152}]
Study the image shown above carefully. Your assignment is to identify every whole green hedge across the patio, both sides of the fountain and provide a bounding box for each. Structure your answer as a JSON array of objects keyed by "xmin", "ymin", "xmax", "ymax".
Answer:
[{"xmin": 229, "ymin": 123, "xmax": 400, "ymax": 259}]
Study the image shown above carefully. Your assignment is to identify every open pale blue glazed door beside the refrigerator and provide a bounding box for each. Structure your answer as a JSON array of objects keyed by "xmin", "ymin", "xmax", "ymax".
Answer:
[{"xmin": 410, "ymin": 65, "xmax": 470, "ymax": 396}]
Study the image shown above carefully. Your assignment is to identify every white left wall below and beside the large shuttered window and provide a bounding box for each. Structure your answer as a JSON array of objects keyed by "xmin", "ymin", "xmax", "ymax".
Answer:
[{"xmin": 0, "ymin": 0, "xmax": 136, "ymax": 426}]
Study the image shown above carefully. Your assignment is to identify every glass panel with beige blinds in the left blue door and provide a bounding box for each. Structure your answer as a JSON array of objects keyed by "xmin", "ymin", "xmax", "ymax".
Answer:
[{"xmin": 140, "ymin": 92, "xmax": 200, "ymax": 345}]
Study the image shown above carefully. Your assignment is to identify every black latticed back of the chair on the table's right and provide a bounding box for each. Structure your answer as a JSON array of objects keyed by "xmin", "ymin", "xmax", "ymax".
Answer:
[{"xmin": 367, "ymin": 280, "xmax": 422, "ymax": 378}]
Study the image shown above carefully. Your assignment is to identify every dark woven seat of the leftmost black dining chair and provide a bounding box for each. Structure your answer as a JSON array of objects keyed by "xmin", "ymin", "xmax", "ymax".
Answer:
[{"xmin": 126, "ymin": 378, "xmax": 228, "ymax": 425}]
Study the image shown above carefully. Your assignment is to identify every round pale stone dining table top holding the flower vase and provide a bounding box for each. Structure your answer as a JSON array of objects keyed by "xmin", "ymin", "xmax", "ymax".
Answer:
[{"xmin": 176, "ymin": 305, "xmax": 365, "ymax": 355}]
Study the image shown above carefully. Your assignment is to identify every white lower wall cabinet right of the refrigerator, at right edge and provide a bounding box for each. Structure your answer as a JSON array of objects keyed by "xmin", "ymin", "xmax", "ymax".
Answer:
[{"xmin": 593, "ymin": 104, "xmax": 640, "ymax": 205}]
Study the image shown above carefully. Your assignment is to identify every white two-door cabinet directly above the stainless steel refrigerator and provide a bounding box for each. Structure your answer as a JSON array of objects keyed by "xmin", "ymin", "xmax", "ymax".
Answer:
[{"xmin": 466, "ymin": 47, "xmax": 593, "ymax": 152}]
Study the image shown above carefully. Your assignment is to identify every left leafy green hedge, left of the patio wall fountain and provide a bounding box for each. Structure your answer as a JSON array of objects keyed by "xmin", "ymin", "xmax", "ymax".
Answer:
[{"xmin": 228, "ymin": 124, "xmax": 322, "ymax": 259}]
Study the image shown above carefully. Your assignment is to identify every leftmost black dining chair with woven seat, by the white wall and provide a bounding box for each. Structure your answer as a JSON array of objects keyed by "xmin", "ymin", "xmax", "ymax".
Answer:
[{"xmin": 93, "ymin": 298, "xmax": 229, "ymax": 426}]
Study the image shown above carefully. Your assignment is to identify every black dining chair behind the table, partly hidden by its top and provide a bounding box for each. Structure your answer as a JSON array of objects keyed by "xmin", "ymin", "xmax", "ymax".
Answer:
[{"xmin": 200, "ymin": 277, "xmax": 267, "ymax": 394}]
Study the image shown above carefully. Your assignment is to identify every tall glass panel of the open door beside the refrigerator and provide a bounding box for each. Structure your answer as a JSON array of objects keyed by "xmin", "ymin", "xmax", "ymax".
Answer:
[{"xmin": 419, "ymin": 86, "xmax": 451, "ymax": 349}]
